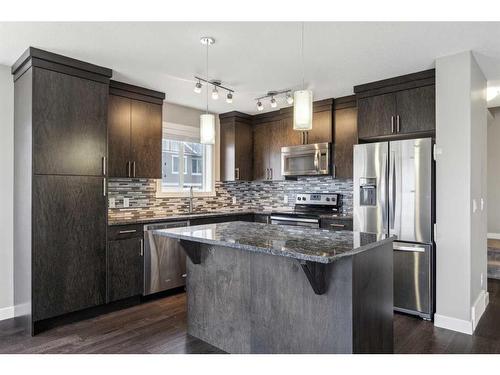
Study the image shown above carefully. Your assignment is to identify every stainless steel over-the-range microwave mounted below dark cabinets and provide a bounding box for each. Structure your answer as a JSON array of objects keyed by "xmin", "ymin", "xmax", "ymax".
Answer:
[{"xmin": 281, "ymin": 143, "xmax": 332, "ymax": 176}]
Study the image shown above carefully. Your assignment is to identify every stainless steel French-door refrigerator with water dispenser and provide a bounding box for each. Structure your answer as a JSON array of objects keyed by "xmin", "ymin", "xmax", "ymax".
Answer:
[{"xmin": 353, "ymin": 138, "xmax": 434, "ymax": 319}]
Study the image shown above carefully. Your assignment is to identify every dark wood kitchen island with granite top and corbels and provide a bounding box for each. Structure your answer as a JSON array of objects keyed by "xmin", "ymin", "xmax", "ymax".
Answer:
[{"xmin": 155, "ymin": 221, "xmax": 393, "ymax": 353}]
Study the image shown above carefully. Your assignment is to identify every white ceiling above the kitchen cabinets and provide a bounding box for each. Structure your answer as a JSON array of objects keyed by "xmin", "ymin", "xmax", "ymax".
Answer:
[{"xmin": 0, "ymin": 22, "xmax": 500, "ymax": 113}]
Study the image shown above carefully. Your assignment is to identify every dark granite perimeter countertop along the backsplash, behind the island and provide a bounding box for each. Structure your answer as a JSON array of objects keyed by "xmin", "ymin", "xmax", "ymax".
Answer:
[{"xmin": 109, "ymin": 210, "xmax": 352, "ymax": 226}]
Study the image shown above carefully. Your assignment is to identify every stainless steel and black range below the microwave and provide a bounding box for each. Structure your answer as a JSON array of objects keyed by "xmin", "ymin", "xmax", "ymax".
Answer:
[{"xmin": 271, "ymin": 193, "xmax": 342, "ymax": 228}]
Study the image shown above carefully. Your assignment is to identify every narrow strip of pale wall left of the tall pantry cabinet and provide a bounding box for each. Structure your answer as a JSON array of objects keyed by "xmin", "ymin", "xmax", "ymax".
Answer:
[{"xmin": 0, "ymin": 65, "xmax": 14, "ymax": 320}]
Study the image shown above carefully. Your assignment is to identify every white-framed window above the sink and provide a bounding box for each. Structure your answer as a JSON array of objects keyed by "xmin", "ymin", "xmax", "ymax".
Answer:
[{"xmin": 157, "ymin": 124, "xmax": 215, "ymax": 196}]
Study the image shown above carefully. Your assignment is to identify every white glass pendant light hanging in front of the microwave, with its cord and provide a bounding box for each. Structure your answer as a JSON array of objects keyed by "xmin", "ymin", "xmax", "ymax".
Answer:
[{"xmin": 293, "ymin": 22, "xmax": 313, "ymax": 131}]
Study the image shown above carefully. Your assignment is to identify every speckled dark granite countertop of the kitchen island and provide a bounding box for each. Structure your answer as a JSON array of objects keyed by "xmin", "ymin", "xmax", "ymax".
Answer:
[{"xmin": 154, "ymin": 221, "xmax": 394, "ymax": 263}]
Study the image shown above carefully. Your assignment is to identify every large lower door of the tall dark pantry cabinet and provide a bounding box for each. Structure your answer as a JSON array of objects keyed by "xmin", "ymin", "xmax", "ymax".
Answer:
[{"xmin": 32, "ymin": 175, "xmax": 107, "ymax": 321}]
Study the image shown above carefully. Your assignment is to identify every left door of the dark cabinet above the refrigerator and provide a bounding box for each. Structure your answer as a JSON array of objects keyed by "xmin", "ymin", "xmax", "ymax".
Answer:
[{"xmin": 358, "ymin": 93, "xmax": 396, "ymax": 139}]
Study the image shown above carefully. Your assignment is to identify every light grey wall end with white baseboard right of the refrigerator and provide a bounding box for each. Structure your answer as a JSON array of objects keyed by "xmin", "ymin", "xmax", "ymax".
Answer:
[{"xmin": 435, "ymin": 51, "xmax": 487, "ymax": 333}]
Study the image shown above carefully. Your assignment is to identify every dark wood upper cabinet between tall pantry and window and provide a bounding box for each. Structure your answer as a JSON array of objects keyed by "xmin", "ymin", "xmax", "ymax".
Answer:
[{"xmin": 108, "ymin": 81, "xmax": 165, "ymax": 178}]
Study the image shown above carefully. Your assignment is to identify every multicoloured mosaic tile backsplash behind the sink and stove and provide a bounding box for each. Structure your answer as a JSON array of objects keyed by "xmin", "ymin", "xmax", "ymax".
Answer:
[{"xmin": 108, "ymin": 176, "xmax": 352, "ymax": 222}]
